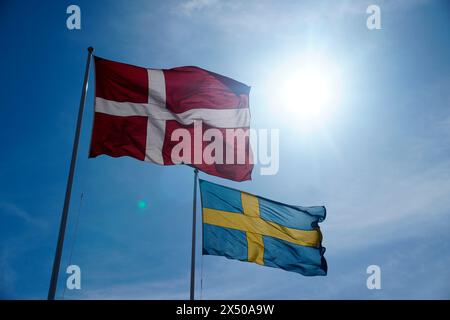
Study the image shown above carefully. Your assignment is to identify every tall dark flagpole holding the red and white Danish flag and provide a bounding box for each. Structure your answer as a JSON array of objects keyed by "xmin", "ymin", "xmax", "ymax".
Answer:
[{"xmin": 47, "ymin": 47, "xmax": 94, "ymax": 300}]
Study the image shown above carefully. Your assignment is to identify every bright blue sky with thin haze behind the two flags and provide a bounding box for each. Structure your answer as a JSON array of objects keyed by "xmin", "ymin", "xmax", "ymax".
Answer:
[{"xmin": 0, "ymin": 0, "xmax": 450, "ymax": 299}]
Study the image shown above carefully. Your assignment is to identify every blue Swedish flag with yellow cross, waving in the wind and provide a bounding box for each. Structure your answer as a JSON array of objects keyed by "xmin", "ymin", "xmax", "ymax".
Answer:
[{"xmin": 200, "ymin": 179, "xmax": 327, "ymax": 276}]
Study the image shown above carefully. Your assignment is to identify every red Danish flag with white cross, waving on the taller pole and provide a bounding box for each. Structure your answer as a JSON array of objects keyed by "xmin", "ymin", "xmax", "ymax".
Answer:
[{"xmin": 89, "ymin": 57, "xmax": 253, "ymax": 181}]
